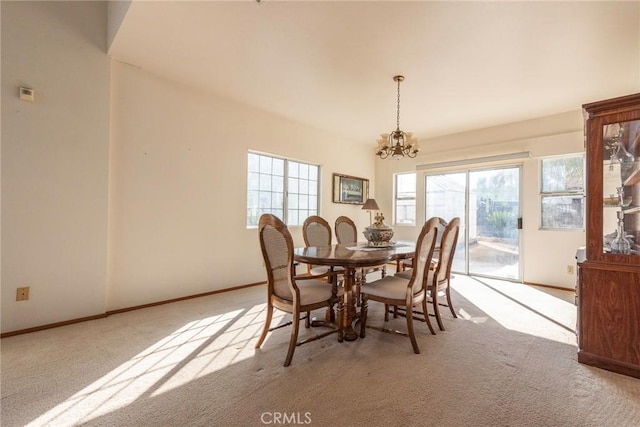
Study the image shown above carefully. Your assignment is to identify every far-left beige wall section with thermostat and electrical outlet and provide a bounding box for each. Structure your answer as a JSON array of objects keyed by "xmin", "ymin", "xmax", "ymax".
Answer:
[{"xmin": 1, "ymin": 2, "xmax": 109, "ymax": 332}]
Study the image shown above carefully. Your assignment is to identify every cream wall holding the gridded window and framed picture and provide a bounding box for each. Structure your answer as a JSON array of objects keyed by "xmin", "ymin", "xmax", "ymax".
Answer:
[{"xmin": 108, "ymin": 61, "xmax": 375, "ymax": 309}]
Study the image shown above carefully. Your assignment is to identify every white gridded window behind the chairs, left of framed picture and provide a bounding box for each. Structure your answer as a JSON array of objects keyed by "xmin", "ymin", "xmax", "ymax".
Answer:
[{"xmin": 247, "ymin": 152, "xmax": 320, "ymax": 227}]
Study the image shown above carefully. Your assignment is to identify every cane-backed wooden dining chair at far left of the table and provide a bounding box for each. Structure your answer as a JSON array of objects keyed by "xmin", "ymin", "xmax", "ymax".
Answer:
[{"xmin": 256, "ymin": 214, "xmax": 338, "ymax": 367}]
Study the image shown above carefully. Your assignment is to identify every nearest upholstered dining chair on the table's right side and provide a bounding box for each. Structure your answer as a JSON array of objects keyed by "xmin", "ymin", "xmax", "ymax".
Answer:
[{"xmin": 360, "ymin": 217, "xmax": 438, "ymax": 354}]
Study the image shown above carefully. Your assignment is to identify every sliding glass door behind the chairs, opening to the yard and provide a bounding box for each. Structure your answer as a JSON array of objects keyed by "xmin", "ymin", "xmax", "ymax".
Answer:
[{"xmin": 425, "ymin": 167, "xmax": 521, "ymax": 281}]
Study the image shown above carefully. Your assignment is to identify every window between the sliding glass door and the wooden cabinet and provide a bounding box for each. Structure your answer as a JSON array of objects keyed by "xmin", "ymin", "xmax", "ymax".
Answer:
[{"xmin": 540, "ymin": 154, "xmax": 584, "ymax": 230}]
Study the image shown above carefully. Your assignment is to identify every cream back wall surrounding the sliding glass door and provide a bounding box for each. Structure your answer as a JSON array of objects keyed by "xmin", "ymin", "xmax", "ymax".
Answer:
[{"xmin": 376, "ymin": 110, "xmax": 585, "ymax": 289}]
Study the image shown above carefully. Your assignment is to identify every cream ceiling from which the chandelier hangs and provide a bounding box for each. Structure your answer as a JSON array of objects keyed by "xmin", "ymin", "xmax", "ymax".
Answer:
[{"xmin": 109, "ymin": 0, "xmax": 640, "ymax": 145}]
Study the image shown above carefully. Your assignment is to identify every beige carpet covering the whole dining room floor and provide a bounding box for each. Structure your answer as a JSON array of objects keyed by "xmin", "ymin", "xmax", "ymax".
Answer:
[{"xmin": 0, "ymin": 276, "xmax": 640, "ymax": 427}]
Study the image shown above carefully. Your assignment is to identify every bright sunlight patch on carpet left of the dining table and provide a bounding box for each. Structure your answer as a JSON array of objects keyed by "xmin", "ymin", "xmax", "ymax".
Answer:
[{"xmin": 29, "ymin": 304, "xmax": 272, "ymax": 426}]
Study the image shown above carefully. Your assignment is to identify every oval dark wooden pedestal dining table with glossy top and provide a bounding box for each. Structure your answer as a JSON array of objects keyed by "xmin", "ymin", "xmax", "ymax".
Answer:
[{"xmin": 293, "ymin": 241, "xmax": 416, "ymax": 341}]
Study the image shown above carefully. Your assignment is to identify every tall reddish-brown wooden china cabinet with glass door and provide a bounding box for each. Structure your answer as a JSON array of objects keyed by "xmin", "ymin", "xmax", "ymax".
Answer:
[{"xmin": 577, "ymin": 94, "xmax": 640, "ymax": 378}]
